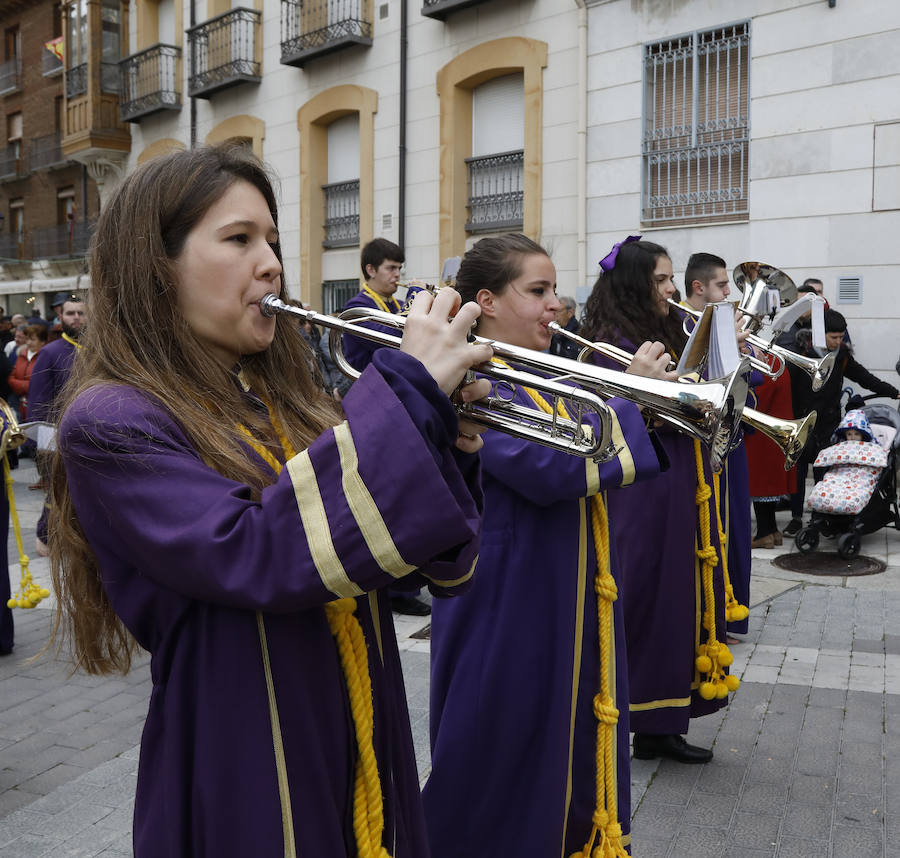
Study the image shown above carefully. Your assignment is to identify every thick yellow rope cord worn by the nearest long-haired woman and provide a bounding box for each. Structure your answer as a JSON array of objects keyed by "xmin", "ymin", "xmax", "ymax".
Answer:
[{"xmin": 238, "ymin": 402, "xmax": 390, "ymax": 858}]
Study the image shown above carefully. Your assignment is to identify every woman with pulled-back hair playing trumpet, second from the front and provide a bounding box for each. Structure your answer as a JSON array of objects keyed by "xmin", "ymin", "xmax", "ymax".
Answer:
[{"xmin": 423, "ymin": 235, "xmax": 665, "ymax": 858}]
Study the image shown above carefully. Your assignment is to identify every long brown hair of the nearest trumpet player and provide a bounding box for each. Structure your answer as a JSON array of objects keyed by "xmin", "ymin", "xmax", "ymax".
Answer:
[{"xmin": 50, "ymin": 146, "xmax": 341, "ymax": 673}]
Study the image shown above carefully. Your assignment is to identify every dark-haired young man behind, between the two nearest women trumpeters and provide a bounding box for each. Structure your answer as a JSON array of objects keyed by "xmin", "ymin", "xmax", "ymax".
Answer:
[{"xmin": 344, "ymin": 238, "xmax": 431, "ymax": 617}]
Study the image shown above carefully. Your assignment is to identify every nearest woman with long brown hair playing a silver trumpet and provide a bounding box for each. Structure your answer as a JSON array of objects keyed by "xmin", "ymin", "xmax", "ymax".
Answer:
[{"xmin": 51, "ymin": 149, "xmax": 490, "ymax": 858}]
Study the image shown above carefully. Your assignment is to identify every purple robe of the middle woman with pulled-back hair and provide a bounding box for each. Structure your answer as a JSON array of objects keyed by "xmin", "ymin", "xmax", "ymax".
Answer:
[{"xmin": 423, "ymin": 392, "xmax": 660, "ymax": 858}]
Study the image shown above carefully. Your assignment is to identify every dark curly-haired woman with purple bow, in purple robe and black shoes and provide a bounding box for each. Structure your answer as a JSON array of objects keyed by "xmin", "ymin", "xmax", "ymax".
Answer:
[{"xmin": 582, "ymin": 236, "xmax": 734, "ymax": 763}]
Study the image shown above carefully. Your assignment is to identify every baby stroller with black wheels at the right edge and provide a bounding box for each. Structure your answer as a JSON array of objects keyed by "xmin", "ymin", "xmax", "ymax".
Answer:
[{"xmin": 794, "ymin": 396, "xmax": 900, "ymax": 560}]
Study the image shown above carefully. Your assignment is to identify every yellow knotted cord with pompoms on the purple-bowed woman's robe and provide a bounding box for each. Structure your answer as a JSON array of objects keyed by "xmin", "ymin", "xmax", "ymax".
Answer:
[{"xmin": 694, "ymin": 440, "xmax": 740, "ymax": 700}]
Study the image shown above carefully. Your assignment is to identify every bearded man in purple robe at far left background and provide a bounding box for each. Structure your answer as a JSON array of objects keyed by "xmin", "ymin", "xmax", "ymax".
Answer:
[{"xmin": 28, "ymin": 295, "xmax": 85, "ymax": 557}]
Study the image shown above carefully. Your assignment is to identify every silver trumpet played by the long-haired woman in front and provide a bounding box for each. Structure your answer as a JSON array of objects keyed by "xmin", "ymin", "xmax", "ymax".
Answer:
[{"xmin": 259, "ymin": 294, "xmax": 747, "ymax": 470}]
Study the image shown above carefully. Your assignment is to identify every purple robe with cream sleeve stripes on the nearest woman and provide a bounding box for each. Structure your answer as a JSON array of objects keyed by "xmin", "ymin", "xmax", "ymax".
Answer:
[{"xmin": 59, "ymin": 350, "xmax": 481, "ymax": 858}]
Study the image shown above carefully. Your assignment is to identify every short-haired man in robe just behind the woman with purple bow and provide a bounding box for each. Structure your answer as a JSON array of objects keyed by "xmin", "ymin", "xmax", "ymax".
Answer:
[{"xmin": 682, "ymin": 253, "xmax": 762, "ymax": 643}]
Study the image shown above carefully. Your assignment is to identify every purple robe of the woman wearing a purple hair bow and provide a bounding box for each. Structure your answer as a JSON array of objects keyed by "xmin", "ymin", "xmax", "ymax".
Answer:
[{"xmin": 595, "ymin": 338, "xmax": 727, "ymax": 734}]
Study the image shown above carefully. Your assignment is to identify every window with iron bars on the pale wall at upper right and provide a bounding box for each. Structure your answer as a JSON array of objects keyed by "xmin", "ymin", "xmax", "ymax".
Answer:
[{"xmin": 641, "ymin": 21, "xmax": 750, "ymax": 226}]
